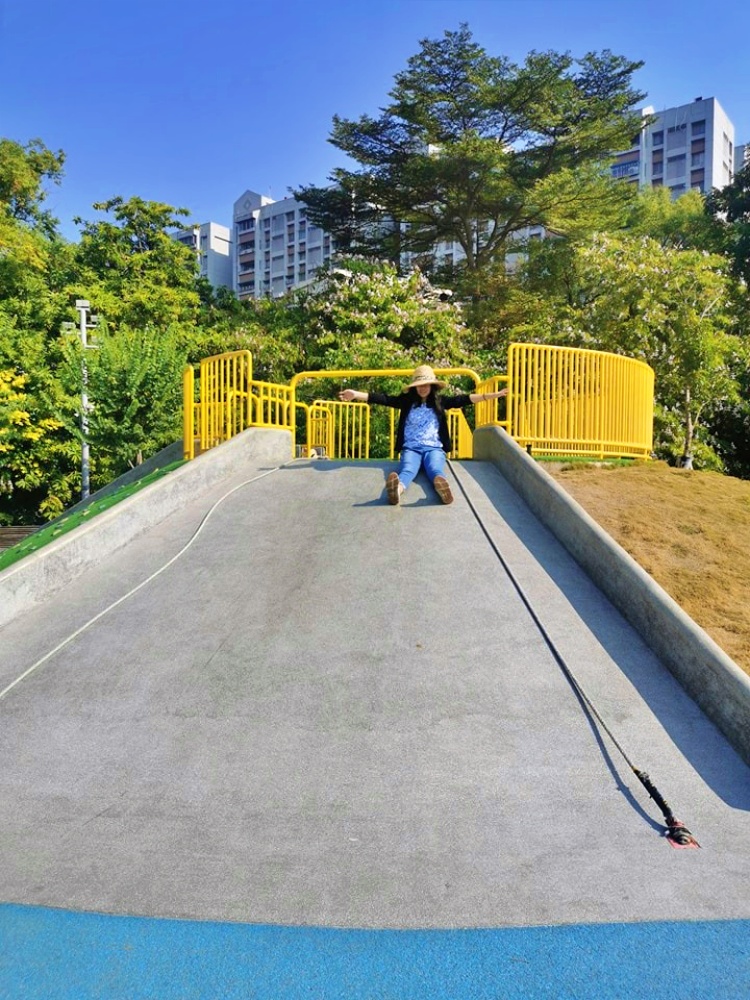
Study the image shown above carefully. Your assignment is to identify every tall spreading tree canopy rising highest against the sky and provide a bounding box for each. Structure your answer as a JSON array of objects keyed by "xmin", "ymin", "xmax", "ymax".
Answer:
[{"xmin": 295, "ymin": 25, "xmax": 643, "ymax": 272}]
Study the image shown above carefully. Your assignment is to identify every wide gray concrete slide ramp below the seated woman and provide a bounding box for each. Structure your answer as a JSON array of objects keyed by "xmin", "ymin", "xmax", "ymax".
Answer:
[{"xmin": 0, "ymin": 461, "xmax": 750, "ymax": 928}]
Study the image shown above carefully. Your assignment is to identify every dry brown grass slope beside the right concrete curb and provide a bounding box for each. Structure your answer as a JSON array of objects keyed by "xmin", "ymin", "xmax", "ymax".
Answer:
[{"xmin": 545, "ymin": 462, "xmax": 750, "ymax": 674}]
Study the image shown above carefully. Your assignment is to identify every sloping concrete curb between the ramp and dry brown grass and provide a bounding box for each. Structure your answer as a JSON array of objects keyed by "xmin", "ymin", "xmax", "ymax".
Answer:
[{"xmin": 474, "ymin": 427, "xmax": 750, "ymax": 764}]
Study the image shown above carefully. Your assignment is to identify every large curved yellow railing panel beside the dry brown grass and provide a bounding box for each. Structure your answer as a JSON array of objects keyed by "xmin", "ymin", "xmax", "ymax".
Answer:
[{"xmin": 508, "ymin": 344, "xmax": 654, "ymax": 458}]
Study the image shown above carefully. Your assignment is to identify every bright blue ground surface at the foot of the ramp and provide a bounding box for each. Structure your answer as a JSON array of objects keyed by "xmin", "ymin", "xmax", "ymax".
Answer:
[{"xmin": 0, "ymin": 905, "xmax": 750, "ymax": 1000}]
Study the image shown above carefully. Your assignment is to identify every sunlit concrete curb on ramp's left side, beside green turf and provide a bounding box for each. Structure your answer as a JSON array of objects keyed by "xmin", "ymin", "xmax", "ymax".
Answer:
[{"xmin": 0, "ymin": 428, "xmax": 292, "ymax": 628}]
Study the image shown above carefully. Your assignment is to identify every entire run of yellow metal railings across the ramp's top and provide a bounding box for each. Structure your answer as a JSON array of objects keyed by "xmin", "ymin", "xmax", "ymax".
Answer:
[{"xmin": 183, "ymin": 344, "xmax": 654, "ymax": 459}]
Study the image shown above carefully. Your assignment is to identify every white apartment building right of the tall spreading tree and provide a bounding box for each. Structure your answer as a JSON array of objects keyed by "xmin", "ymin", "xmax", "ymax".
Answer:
[{"xmin": 612, "ymin": 97, "xmax": 735, "ymax": 198}]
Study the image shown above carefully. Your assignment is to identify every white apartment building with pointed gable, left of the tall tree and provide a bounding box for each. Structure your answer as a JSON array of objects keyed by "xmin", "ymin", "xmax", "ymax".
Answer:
[{"xmin": 233, "ymin": 191, "xmax": 334, "ymax": 299}]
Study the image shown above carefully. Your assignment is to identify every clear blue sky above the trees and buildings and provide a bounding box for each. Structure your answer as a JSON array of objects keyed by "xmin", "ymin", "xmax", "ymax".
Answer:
[{"xmin": 0, "ymin": 0, "xmax": 750, "ymax": 239}]
